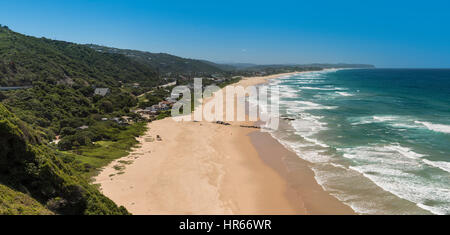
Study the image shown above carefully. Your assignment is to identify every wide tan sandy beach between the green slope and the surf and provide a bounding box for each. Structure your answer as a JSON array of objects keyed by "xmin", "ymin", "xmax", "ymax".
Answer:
[{"xmin": 95, "ymin": 71, "xmax": 354, "ymax": 215}]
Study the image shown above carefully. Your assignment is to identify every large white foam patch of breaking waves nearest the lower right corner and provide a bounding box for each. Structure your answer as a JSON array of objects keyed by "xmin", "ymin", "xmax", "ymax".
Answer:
[{"xmin": 340, "ymin": 144, "xmax": 450, "ymax": 213}]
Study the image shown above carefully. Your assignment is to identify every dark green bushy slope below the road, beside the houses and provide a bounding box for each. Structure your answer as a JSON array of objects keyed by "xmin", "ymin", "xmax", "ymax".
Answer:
[{"xmin": 3, "ymin": 82, "xmax": 137, "ymax": 141}]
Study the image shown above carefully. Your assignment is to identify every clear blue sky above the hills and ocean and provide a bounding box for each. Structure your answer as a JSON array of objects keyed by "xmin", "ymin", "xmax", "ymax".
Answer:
[{"xmin": 0, "ymin": 0, "xmax": 450, "ymax": 68}]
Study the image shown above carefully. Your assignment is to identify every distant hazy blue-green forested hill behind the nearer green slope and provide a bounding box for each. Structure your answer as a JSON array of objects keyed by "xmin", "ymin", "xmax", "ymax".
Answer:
[{"xmin": 88, "ymin": 44, "xmax": 223, "ymax": 74}]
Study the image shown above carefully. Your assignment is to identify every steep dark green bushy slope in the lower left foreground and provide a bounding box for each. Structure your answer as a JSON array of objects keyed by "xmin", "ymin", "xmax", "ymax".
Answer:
[{"xmin": 0, "ymin": 104, "xmax": 128, "ymax": 214}]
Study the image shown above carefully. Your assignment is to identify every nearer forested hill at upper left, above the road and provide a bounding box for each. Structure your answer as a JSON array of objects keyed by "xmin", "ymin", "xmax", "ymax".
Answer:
[{"xmin": 0, "ymin": 27, "xmax": 161, "ymax": 86}]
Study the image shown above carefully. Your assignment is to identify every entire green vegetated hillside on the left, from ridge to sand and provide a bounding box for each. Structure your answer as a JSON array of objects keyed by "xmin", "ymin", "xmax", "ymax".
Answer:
[{"xmin": 0, "ymin": 27, "xmax": 156, "ymax": 214}]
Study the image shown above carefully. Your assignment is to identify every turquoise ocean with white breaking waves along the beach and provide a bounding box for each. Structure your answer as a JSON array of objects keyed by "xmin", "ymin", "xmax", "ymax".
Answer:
[{"xmin": 256, "ymin": 69, "xmax": 450, "ymax": 214}]
